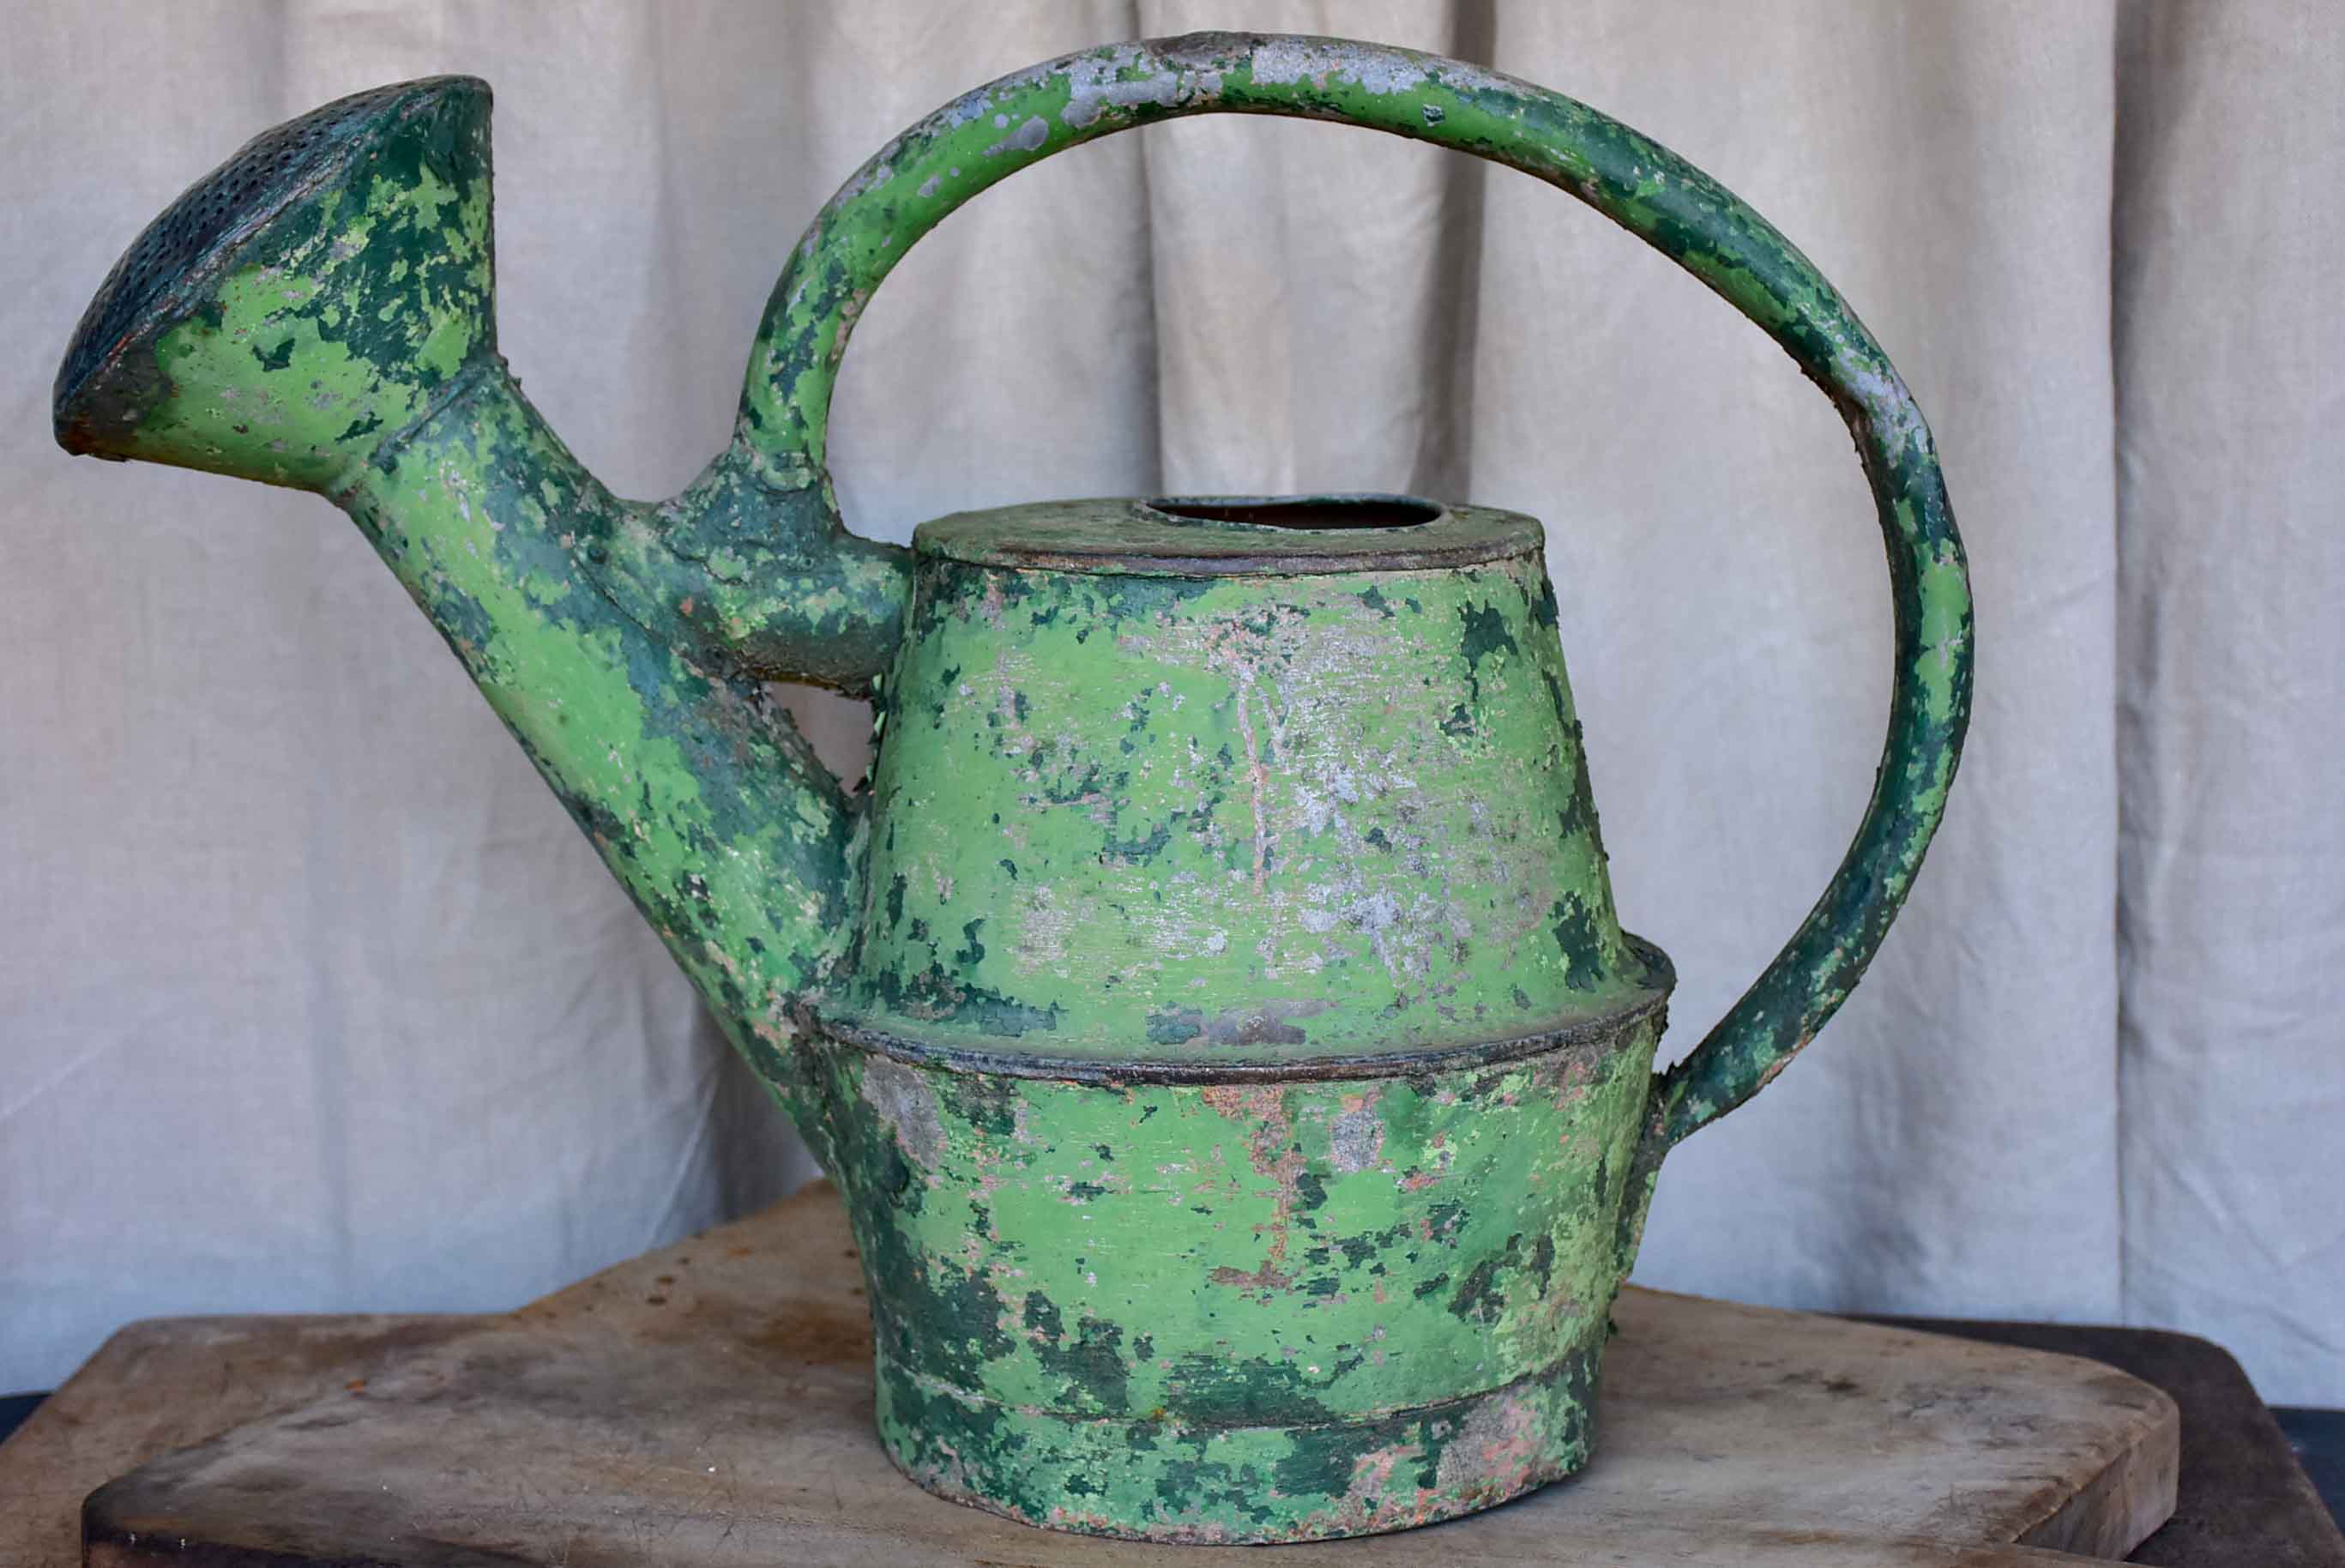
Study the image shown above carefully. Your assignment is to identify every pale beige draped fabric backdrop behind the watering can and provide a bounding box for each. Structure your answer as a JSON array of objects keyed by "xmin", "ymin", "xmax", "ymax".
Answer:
[{"xmin": 0, "ymin": 0, "xmax": 2345, "ymax": 1404}]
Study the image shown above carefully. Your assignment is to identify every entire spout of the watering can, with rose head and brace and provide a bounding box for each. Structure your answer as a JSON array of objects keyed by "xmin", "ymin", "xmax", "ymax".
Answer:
[{"xmin": 54, "ymin": 77, "xmax": 905, "ymax": 1108}]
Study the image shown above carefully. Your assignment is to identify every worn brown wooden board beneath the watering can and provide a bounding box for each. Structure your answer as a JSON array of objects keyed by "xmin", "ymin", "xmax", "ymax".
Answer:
[{"xmin": 0, "ymin": 1188, "xmax": 2179, "ymax": 1568}]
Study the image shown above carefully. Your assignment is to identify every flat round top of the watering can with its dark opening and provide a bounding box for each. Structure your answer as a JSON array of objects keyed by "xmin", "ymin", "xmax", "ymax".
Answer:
[{"xmin": 913, "ymin": 495, "xmax": 1546, "ymax": 576}]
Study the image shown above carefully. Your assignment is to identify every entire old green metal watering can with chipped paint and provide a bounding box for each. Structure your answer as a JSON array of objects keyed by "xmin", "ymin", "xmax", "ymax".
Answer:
[{"xmin": 57, "ymin": 33, "xmax": 1970, "ymax": 1542}]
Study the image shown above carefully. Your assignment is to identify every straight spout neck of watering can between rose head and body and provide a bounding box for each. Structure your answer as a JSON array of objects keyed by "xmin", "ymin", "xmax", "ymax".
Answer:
[{"xmin": 335, "ymin": 371, "xmax": 860, "ymax": 1083}]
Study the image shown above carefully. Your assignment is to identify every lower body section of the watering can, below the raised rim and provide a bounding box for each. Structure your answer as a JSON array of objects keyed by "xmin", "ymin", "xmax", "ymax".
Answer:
[{"xmin": 802, "ymin": 1015, "xmax": 1661, "ymax": 1542}]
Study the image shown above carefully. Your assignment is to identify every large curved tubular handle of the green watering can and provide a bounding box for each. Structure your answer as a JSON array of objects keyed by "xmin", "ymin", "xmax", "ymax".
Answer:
[{"xmin": 740, "ymin": 33, "xmax": 1970, "ymax": 1158}]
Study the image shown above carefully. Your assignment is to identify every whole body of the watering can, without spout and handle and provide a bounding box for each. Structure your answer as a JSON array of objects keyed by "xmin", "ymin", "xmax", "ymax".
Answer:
[{"xmin": 816, "ymin": 497, "xmax": 1670, "ymax": 1540}]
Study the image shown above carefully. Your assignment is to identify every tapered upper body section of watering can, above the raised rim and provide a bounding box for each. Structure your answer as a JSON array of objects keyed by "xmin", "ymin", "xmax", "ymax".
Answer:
[{"xmin": 844, "ymin": 502, "xmax": 1667, "ymax": 1071}]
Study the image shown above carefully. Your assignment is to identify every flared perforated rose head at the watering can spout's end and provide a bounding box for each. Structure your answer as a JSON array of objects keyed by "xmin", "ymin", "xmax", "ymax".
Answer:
[{"xmin": 54, "ymin": 77, "xmax": 497, "ymax": 490}]
